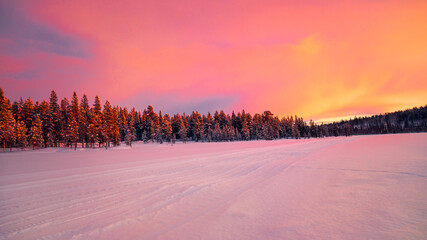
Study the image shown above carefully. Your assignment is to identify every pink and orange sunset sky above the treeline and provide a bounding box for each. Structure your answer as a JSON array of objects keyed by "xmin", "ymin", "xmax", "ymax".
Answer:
[{"xmin": 0, "ymin": 0, "xmax": 427, "ymax": 121}]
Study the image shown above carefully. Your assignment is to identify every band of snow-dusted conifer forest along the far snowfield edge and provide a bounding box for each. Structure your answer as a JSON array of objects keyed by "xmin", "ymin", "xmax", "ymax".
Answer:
[{"xmin": 0, "ymin": 88, "xmax": 427, "ymax": 151}]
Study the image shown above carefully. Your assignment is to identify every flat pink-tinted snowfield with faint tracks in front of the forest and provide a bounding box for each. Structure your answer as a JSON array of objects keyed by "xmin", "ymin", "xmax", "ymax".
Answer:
[{"xmin": 0, "ymin": 134, "xmax": 427, "ymax": 239}]
